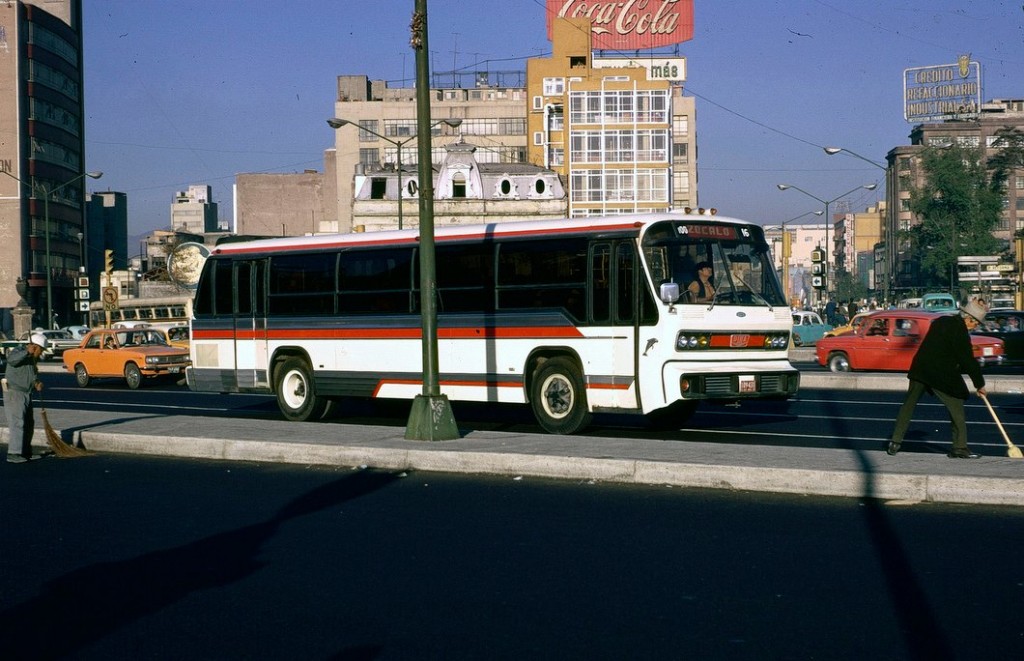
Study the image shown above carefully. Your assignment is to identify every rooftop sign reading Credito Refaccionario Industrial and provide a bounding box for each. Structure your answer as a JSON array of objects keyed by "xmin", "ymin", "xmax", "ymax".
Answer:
[{"xmin": 903, "ymin": 54, "xmax": 981, "ymax": 124}]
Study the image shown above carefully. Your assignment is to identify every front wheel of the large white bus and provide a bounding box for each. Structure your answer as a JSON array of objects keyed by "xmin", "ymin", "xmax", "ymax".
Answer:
[{"xmin": 529, "ymin": 358, "xmax": 591, "ymax": 434}]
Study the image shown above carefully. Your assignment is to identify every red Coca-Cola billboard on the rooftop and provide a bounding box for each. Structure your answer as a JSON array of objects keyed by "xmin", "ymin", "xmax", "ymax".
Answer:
[{"xmin": 547, "ymin": 0, "xmax": 693, "ymax": 50}]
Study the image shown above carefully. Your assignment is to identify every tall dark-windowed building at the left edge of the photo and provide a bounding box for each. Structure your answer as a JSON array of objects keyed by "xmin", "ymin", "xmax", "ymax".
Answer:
[{"xmin": 0, "ymin": 0, "xmax": 89, "ymax": 333}]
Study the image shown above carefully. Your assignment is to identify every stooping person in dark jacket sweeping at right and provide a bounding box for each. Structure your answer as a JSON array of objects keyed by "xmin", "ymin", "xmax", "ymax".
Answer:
[{"xmin": 886, "ymin": 300, "xmax": 988, "ymax": 459}]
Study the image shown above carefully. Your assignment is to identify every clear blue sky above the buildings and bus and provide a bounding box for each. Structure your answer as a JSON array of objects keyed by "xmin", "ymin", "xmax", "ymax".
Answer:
[{"xmin": 83, "ymin": 0, "xmax": 1024, "ymax": 234}]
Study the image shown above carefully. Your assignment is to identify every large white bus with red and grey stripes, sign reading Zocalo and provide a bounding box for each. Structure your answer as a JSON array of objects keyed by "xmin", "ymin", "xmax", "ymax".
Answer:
[{"xmin": 186, "ymin": 213, "xmax": 800, "ymax": 434}]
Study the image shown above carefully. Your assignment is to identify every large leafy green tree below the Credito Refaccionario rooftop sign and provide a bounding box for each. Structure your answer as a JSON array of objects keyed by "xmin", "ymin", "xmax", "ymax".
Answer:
[{"xmin": 904, "ymin": 144, "xmax": 1006, "ymax": 291}]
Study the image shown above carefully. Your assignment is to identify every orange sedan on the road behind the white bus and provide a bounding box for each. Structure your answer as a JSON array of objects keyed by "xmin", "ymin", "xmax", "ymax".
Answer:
[{"xmin": 63, "ymin": 328, "xmax": 189, "ymax": 390}]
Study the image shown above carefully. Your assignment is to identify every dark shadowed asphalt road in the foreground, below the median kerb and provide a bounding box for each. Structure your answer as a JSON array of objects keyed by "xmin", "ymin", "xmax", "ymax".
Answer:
[{"xmin": 0, "ymin": 455, "xmax": 1024, "ymax": 661}]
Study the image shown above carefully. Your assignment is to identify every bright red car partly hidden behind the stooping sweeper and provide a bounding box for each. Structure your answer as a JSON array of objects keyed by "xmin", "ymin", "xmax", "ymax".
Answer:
[{"xmin": 815, "ymin": 310, "xmax": 1002, "ymax": 371}]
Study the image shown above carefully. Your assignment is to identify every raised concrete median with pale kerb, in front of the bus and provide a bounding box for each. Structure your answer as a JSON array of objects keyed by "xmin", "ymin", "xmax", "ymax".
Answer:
[{"xmin": 0, "ymin": 386, "xmax": 1024, "ymax": 505}]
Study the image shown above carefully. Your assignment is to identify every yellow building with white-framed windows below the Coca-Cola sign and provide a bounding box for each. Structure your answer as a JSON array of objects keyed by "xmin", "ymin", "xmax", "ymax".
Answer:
[{"xmin": 526, "ymin": 18, "xmax": 696, "ymax": 216}]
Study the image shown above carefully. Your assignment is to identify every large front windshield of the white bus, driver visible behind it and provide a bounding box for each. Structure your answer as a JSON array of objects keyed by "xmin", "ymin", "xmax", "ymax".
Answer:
[{"xmin": 641, "ymin": 220, "xmax": 785, "ymax": 307}]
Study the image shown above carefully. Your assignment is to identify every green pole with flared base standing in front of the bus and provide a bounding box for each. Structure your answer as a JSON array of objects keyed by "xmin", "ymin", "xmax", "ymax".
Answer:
[{"xmin": 399, "ymin": 0, "xmax": 459, "ymax": 441}]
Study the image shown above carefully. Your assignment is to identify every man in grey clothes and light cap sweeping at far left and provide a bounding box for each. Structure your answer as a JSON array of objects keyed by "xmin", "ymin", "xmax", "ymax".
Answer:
[{"xmin": 3, "ymin": 333, "xmax": 48, "ymax": 464}]
